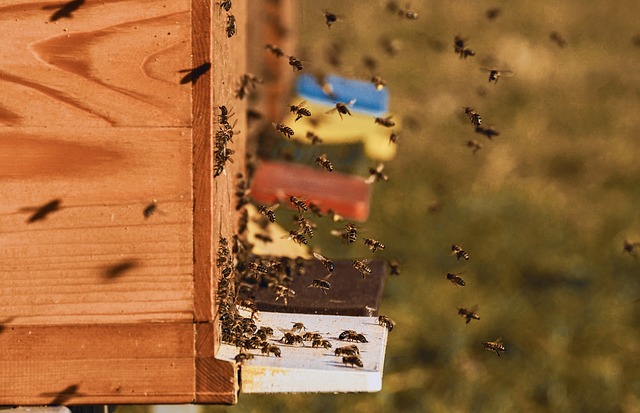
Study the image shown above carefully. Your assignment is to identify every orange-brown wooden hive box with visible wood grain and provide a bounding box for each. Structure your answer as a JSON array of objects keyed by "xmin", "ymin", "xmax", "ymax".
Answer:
[{"xmin": 0, "ymin": 0, "xmax": 247, "ymax": 405}]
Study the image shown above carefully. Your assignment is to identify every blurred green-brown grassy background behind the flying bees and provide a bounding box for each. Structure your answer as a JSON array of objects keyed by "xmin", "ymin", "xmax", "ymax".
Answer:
[{"xmin": 125, "ymin": 0, "xmax": 640, "ymax": 413}]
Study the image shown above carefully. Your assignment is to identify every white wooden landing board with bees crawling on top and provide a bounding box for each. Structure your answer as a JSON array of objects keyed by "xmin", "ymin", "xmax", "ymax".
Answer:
[{"xmin": 217, "ymin": 312, "xmax": 388, "ymax": 393}]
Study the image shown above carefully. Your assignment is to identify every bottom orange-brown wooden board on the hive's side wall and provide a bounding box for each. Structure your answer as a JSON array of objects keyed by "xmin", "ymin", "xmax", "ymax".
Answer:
[{"xmin": 0, "ymin": 323, "xmax": 195, "ymax": 405}]
